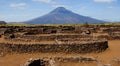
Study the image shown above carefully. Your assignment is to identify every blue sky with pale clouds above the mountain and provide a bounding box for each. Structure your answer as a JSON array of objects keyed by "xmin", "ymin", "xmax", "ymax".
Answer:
[{"xmin": 0, "ymin": 0, "xmax": 120, "ymax": 22}]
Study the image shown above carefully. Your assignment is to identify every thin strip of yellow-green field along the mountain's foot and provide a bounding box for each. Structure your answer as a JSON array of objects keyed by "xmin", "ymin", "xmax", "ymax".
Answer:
[{"xmin": 1, "ymin": 22, "xmax": 120, "ymax": 26}]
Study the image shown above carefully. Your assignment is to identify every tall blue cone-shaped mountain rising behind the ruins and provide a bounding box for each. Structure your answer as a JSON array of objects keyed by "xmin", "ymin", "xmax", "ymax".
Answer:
[{"xmin": 25, "ymin": 7, "xmax": 104, "ymax": 24}]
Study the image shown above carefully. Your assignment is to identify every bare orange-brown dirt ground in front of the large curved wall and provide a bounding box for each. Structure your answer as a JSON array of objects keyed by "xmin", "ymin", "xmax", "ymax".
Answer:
[{"xmin": 0, "ymin": 40, "xmax": 120, "ymax": 66}]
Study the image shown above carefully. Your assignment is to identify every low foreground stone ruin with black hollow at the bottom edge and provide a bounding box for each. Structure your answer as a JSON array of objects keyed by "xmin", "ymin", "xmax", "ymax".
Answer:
[{"xmin": 23, "ymin": 56, "xmax": 98, "ymax": 66}]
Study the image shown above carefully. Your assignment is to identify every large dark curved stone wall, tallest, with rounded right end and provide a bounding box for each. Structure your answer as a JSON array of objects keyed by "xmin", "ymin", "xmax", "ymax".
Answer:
[{"xmin": 0, "ymin": 41, "xmax": 108, "ymax": 53}]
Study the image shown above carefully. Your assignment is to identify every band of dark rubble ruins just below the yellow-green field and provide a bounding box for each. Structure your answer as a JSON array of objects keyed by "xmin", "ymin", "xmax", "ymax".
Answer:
[{"xmin": 0, "ymin": 26, "xmax": 120, "ymax": 40}]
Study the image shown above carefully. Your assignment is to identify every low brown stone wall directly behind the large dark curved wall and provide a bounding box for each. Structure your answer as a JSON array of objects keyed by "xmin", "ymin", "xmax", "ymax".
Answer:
[{"xmin": 9, "ymin": 35, "xmax": 92, "ymax": 42}]
